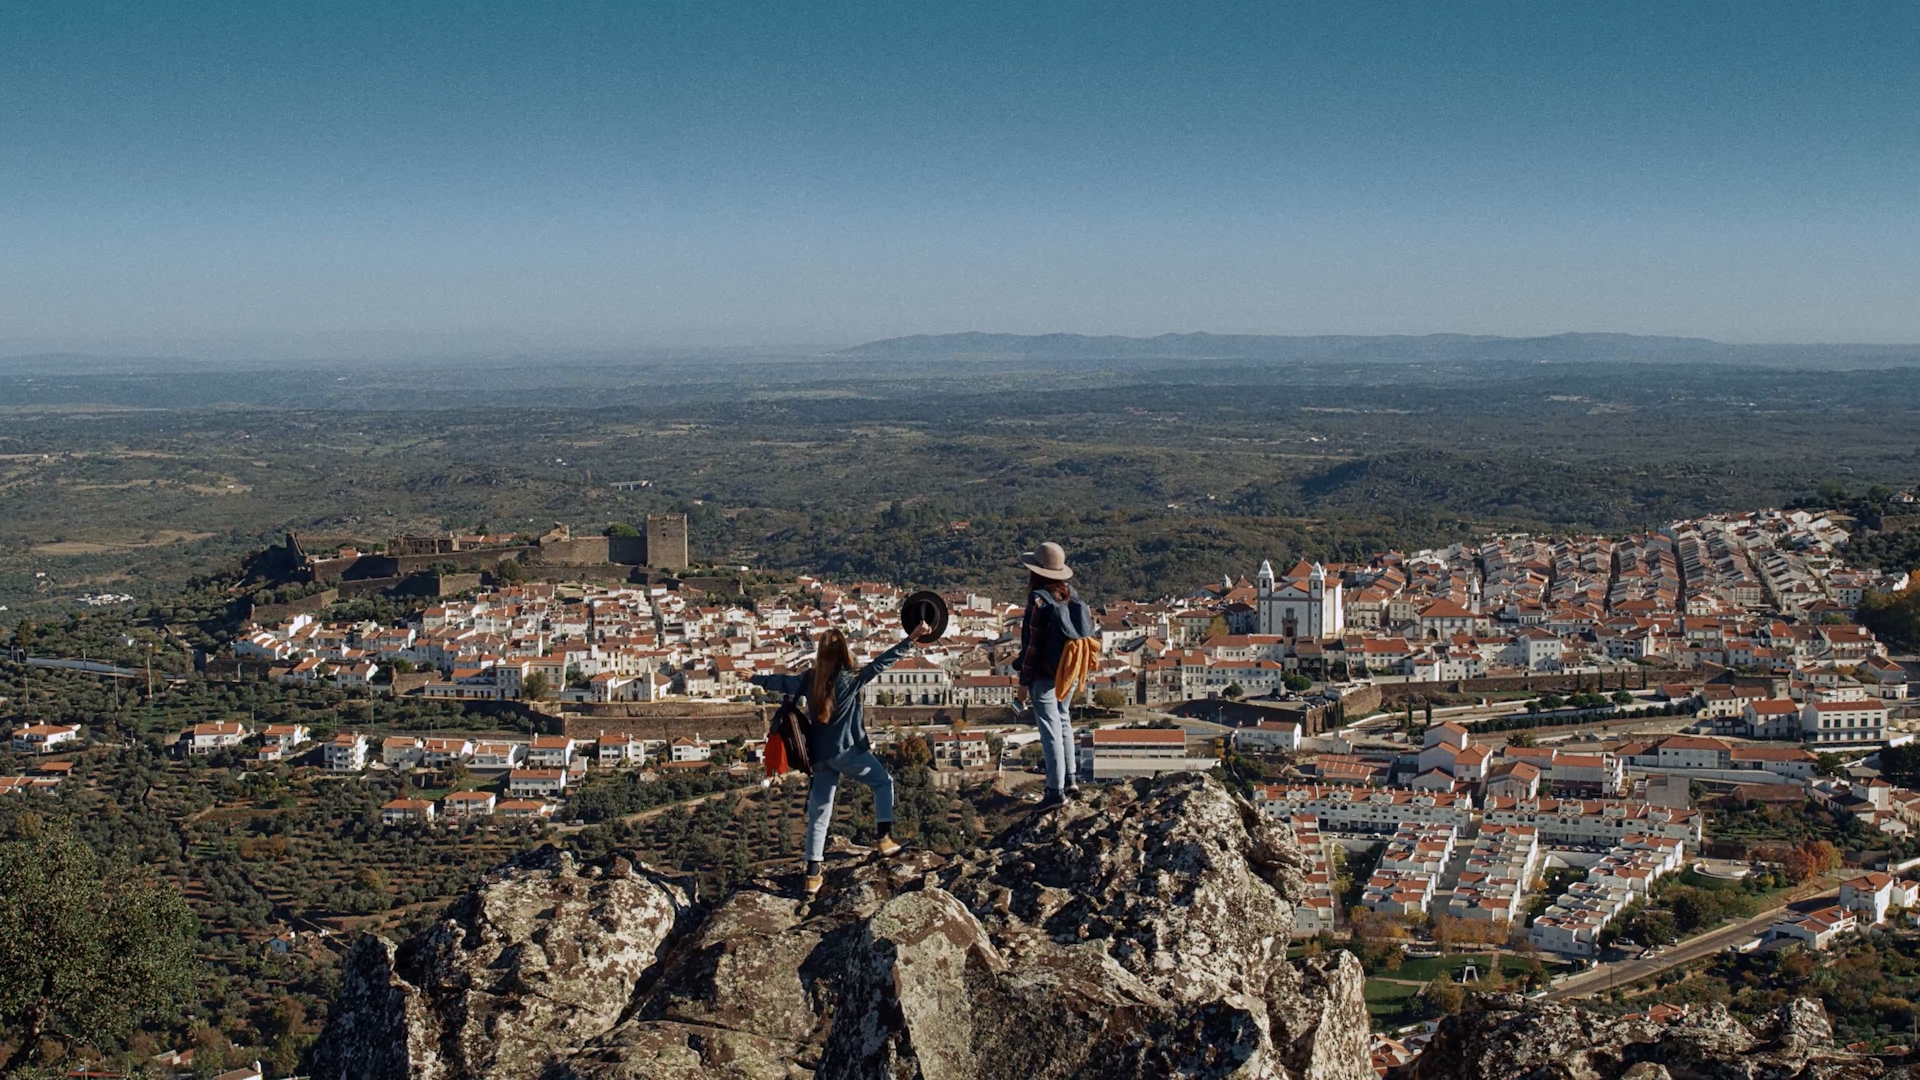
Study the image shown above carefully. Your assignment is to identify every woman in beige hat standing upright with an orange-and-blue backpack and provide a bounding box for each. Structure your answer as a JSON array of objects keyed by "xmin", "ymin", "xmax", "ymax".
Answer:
[{"xmin": 1020, "ymin": 542, "xmax": 1091, "ymax": 813}]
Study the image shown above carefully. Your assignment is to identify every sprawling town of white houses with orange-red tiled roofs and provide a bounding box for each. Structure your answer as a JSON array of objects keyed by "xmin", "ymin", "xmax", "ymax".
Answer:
[{"xmin": 11, "ymin": 511, "xmax": 1920, "ymax": 1065}]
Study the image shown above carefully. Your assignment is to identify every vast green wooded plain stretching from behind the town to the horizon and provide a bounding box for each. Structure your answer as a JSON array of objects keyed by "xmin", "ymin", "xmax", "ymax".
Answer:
[{"xmin": 0, "ymin": 356, "xmax": 1920, "ymax": 623}]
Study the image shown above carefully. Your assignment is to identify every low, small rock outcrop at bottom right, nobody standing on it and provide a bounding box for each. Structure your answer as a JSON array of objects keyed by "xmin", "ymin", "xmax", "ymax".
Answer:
[{"xmin": 1388, "ymin": 995, "xmax": 1905, "ymax": 1080}]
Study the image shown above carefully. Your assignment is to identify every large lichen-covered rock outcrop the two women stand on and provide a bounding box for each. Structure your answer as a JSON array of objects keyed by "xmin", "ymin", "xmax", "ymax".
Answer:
[{"xmin": 311, "ymin": 776, "xmax": 1373, "ymax": 1080}]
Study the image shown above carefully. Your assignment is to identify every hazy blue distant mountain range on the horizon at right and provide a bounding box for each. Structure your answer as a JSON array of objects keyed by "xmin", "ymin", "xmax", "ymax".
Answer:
[{"xmin": 843, "ymin": 332, "xmax": 1920, "ymax": 367}]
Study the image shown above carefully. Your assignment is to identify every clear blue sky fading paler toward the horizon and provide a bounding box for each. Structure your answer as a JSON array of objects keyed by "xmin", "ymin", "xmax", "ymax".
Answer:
[{"xmin": 0, "ymin": 0, "xmax": 1920, "ymax": 354}]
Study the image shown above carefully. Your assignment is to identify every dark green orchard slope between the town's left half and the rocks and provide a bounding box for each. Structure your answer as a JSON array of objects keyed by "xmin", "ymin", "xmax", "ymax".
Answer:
[{"xmin": 0, "ymin": 703, "xmax": 1016, "ymax": 1072}]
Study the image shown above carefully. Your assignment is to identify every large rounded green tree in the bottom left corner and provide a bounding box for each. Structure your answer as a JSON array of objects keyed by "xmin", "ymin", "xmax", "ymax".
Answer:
[{"xmin": 0, "ymin": 828, "xmax": 196, "ymax": 1072}]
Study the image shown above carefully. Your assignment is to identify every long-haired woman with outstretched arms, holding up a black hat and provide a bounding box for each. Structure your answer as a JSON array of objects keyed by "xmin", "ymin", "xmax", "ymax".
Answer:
[{"xmin": 751, "ymin": 623, "xmax": 931, "ymax": 897}]
